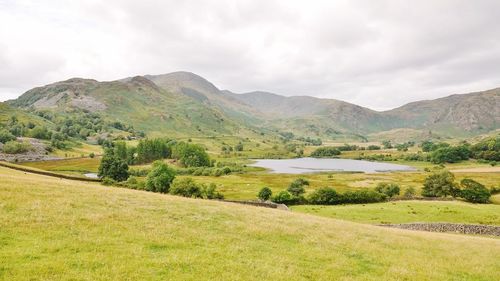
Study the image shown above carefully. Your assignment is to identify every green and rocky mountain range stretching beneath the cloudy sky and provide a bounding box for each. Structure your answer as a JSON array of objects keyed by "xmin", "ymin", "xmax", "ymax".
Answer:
[{"xmin": 7, "ymin": 72, "xmax": 500, "ymax": 139}]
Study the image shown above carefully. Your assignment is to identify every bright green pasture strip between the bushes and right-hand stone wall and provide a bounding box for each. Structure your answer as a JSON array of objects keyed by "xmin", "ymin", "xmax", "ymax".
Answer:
[{"xmin": 292, "ymin": 201, "xmax": 500, "ymax": 225}]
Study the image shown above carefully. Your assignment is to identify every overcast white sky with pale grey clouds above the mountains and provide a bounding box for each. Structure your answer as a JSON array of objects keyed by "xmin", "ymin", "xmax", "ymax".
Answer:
[{"xmin": 0, "ymin": 0, "xmax": 500, "ymax": 110}]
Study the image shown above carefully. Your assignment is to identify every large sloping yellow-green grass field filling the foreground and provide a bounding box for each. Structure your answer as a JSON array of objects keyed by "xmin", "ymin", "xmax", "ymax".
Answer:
[{"xmin": 0, "ymin": 165, "xmax": 500, "ymax": 280}]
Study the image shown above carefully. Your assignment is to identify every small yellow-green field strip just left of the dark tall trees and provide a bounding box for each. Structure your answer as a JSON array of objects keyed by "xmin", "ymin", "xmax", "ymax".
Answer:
[{"xmin": 22, "ymin": 157, "xmax": 101, "ymax": 174}]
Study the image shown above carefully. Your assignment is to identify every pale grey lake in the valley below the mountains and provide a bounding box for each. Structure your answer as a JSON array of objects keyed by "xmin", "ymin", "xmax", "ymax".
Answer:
[{"xmin": 249, "ymin": 158, "xmax": 416, "ymax": 174}]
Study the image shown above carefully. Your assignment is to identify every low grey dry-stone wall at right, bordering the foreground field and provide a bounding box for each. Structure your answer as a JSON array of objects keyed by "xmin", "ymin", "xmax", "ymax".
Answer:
[{"xmin": 380, "ymin": 222, "xmax": 500, "ymax": 236}]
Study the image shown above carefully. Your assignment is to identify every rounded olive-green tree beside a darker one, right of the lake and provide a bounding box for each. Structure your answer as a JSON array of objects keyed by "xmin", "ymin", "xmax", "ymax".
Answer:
[{"xmin": 422, "ymin": 170, "xmax": 458, "ymax": 197}]
